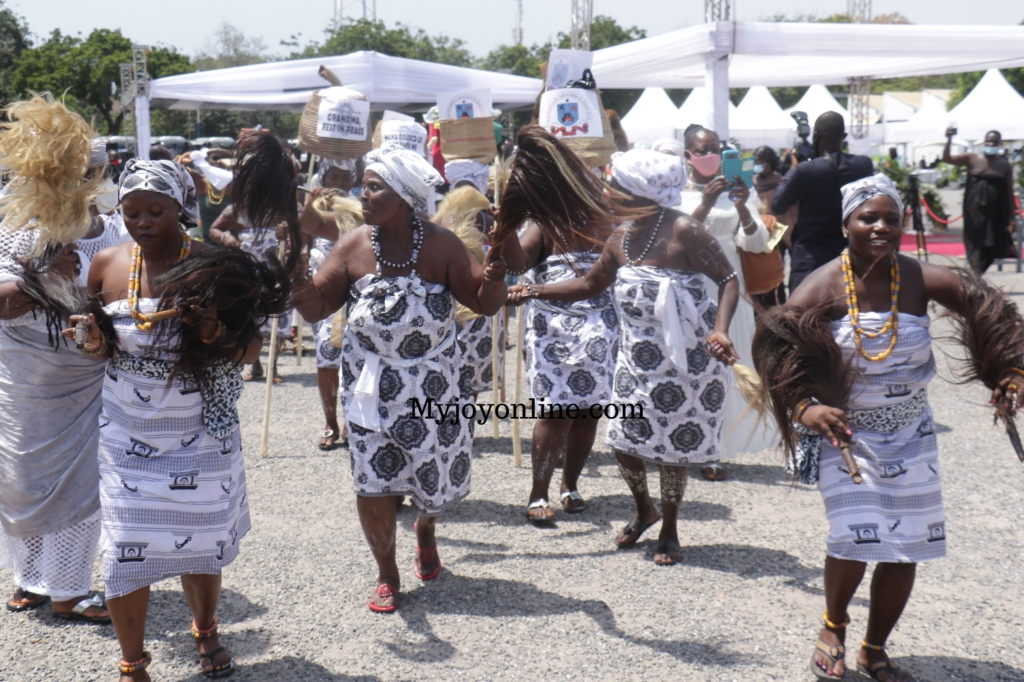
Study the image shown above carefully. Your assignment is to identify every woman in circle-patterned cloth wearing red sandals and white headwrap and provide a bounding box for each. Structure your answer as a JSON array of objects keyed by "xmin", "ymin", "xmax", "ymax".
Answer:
[{"xmin": 292, "ymin": 144, "xmax": 507, "ymax": 612}]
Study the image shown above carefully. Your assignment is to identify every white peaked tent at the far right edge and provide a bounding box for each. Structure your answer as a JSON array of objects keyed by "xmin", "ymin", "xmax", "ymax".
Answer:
[{"xmin": 948, "ymin": 68, "xmax": 1024, "ymax": 139}]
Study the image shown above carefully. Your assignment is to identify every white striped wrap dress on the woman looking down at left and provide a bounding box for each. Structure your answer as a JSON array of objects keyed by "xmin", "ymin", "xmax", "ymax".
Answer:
[{"xmin": 99, "ymin": 298, "xmax": 250, "ymax": 597}]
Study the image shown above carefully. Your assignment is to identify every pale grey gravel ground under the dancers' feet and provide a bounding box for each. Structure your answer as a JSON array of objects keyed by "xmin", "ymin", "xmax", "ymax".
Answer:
[{"xmin": 0, "ymin": 262, "xmax": 1024, "ymax": 682}]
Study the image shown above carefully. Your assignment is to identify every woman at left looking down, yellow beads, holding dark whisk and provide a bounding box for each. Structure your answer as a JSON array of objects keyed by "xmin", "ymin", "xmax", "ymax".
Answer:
[{"xmin": 63, "ymin": 159, "xmax": 294, "ymax": 682}]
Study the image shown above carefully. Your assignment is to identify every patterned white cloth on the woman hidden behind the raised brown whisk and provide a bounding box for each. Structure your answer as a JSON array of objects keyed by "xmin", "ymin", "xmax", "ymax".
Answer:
[{"xmin": 523, "ymin": 253, "xmax": 618, "ymax": 409}]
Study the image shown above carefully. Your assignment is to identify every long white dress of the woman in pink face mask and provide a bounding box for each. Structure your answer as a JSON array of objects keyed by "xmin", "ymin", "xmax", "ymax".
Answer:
[{"xmin": 679, "ymin": 183, "xmax": 778, "ymax": 459}]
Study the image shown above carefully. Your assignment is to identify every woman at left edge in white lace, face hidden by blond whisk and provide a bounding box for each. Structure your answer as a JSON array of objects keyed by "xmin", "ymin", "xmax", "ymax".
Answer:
[{"xmin": 0, "ymin": 100, "xmax": 123, "ymax": 624}]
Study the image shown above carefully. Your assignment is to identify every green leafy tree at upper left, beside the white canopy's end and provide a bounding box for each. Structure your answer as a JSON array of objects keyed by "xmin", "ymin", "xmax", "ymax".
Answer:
[{"xmin": 12, "ymin": 29, "xmax": 190, "ymax": 135}]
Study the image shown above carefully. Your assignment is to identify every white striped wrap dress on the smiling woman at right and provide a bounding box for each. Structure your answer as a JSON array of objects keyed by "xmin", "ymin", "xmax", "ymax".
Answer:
[{"xmin": 818, "ymin": 312, "xmax": 946, "ymax": 562}]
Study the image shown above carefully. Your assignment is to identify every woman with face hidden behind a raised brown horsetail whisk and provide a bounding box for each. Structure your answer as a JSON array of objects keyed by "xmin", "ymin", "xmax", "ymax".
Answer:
[{"xmin": 499, "ymin": 126, "xmax": 618, "ymax": 523}]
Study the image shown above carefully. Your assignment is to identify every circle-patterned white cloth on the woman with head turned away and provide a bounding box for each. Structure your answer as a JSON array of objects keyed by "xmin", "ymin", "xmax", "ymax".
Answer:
[{"xmin": 607, "ymin": 265, "xmax": 731, "ymax": 466}]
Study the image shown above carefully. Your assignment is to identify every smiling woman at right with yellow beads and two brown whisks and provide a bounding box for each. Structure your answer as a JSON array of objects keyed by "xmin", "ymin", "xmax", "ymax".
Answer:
[{"xmin": 755, "ymin": 175, "xmax": 1024, "ymax": 682}]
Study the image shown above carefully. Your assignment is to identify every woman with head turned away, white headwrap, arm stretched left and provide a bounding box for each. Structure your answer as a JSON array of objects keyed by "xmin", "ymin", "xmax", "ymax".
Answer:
[{"xmin": 509, "ymin": 150, "xmax": 739, "ymax": 565}]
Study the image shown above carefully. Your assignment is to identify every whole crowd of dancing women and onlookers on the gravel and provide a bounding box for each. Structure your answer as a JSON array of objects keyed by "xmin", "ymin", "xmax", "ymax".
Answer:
[{"xmin": 0, "ymin": 91, "xmax": 1024, "ymax": 682}]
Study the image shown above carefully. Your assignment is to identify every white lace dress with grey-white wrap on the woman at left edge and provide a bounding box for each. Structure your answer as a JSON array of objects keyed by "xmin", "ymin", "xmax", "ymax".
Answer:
[{"xmin": 0, "ymin": 219, "xmax": 126, "ymax": 601}]
